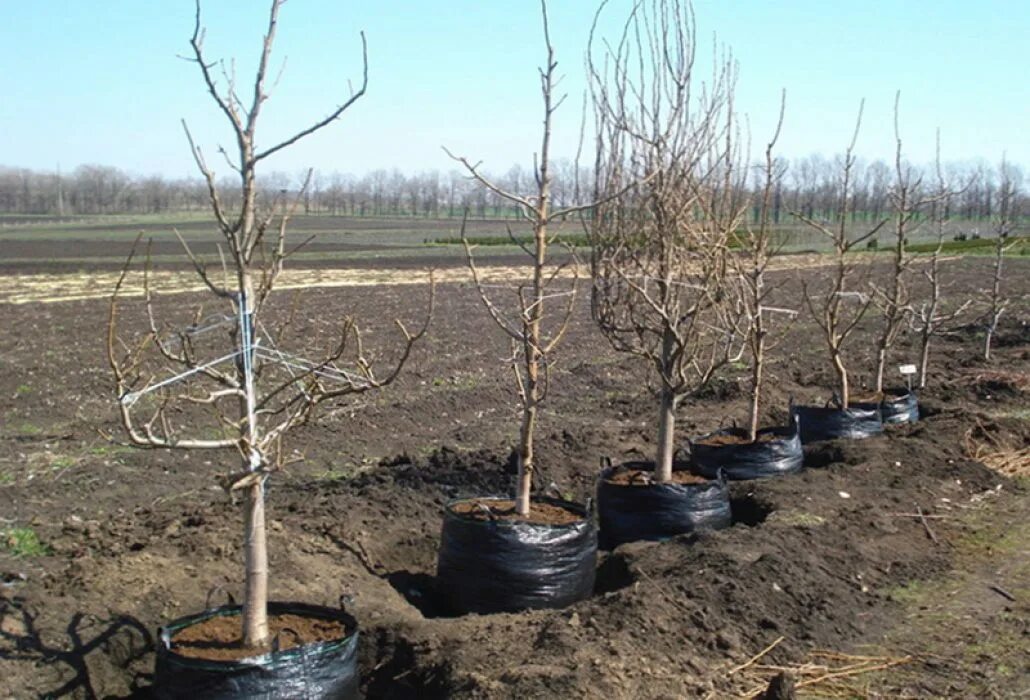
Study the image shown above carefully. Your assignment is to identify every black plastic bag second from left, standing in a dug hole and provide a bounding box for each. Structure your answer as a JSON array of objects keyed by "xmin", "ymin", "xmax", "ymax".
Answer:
[{"xmin": 437, "ymin": 498, "xmax": 597, "ymax": 613}]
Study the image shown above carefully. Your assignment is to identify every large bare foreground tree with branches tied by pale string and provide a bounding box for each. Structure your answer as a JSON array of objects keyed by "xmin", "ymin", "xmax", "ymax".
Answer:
[{"xmin": 107, "ymin": 0, "xmax": 433, "ymax": 649}]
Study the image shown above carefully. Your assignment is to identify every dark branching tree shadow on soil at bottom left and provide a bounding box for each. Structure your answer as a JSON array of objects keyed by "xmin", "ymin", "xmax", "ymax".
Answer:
[{"xmin": 0, "ymin": 598, "xmax": 153, "ymax": 700}]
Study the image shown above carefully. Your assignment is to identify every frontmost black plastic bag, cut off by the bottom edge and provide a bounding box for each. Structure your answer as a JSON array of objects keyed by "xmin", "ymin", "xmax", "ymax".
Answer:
[{"xmin": 152, "ymin": 603, "xmax": 361, "ymax": 700}]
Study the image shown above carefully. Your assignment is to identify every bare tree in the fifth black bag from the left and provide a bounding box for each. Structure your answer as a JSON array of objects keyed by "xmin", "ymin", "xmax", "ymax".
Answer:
[{"xmin": 791, "ymin": 100, "xmax": 889, "ymax": 409}]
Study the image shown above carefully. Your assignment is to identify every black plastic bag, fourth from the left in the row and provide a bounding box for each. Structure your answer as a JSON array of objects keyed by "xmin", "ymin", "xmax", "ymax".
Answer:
[{"xmin": 690, "ymin": 425, "xmax": 804, "ymax": 480}]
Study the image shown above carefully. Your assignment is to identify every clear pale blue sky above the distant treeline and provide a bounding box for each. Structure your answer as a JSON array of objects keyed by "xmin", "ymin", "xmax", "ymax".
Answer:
[{"xmin": 0, "ymin": 0, "xmax": 1030, "ymax": 177}]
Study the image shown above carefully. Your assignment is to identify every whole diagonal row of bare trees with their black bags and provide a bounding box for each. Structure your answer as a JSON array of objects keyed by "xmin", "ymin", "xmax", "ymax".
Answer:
[{"xmin": 102, "ymin": 0, "xmax": 988, "ymax": 698}]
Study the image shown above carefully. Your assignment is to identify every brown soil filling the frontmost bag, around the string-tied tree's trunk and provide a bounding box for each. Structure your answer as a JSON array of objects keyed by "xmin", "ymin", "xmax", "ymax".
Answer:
[{"xmin": 172, "ymin": 614, "xmax": 348, "ymax": 661}]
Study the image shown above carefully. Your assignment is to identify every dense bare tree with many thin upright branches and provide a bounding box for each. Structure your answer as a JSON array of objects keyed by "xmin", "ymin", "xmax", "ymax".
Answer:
[{"xmin": 589, "ymin": 0, "xmax": 747, "ymax": 483}]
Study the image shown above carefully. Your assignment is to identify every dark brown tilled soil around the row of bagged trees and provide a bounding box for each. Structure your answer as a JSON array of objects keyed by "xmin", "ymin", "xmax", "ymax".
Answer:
[{"xmin": 0, "ymin": 258, "xmax": 1030, "ymax": 699}]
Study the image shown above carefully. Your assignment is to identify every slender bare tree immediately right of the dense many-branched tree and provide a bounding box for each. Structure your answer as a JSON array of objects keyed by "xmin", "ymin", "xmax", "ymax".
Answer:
[{"xmin": 731, "ymin": 91, "xmax": 797, "ymax": 442}]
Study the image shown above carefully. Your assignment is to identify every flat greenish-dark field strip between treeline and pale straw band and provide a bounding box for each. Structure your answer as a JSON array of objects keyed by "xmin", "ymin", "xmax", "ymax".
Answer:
[{"xmin": 0, "ymin": 214, "xmax": 1030, "ymax": 269}]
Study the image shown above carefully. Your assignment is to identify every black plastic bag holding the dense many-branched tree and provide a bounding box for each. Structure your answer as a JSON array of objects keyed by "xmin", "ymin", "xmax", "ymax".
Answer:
[{"xmin": 597, "ymin": 462, "xmax": 732, "ymax": 549}]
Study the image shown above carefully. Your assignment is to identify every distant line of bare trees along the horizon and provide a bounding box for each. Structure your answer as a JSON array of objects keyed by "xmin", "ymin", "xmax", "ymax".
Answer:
[{"xmin": 0, "ymin": 155, "xmax": 1030, "ymax": 223}]
